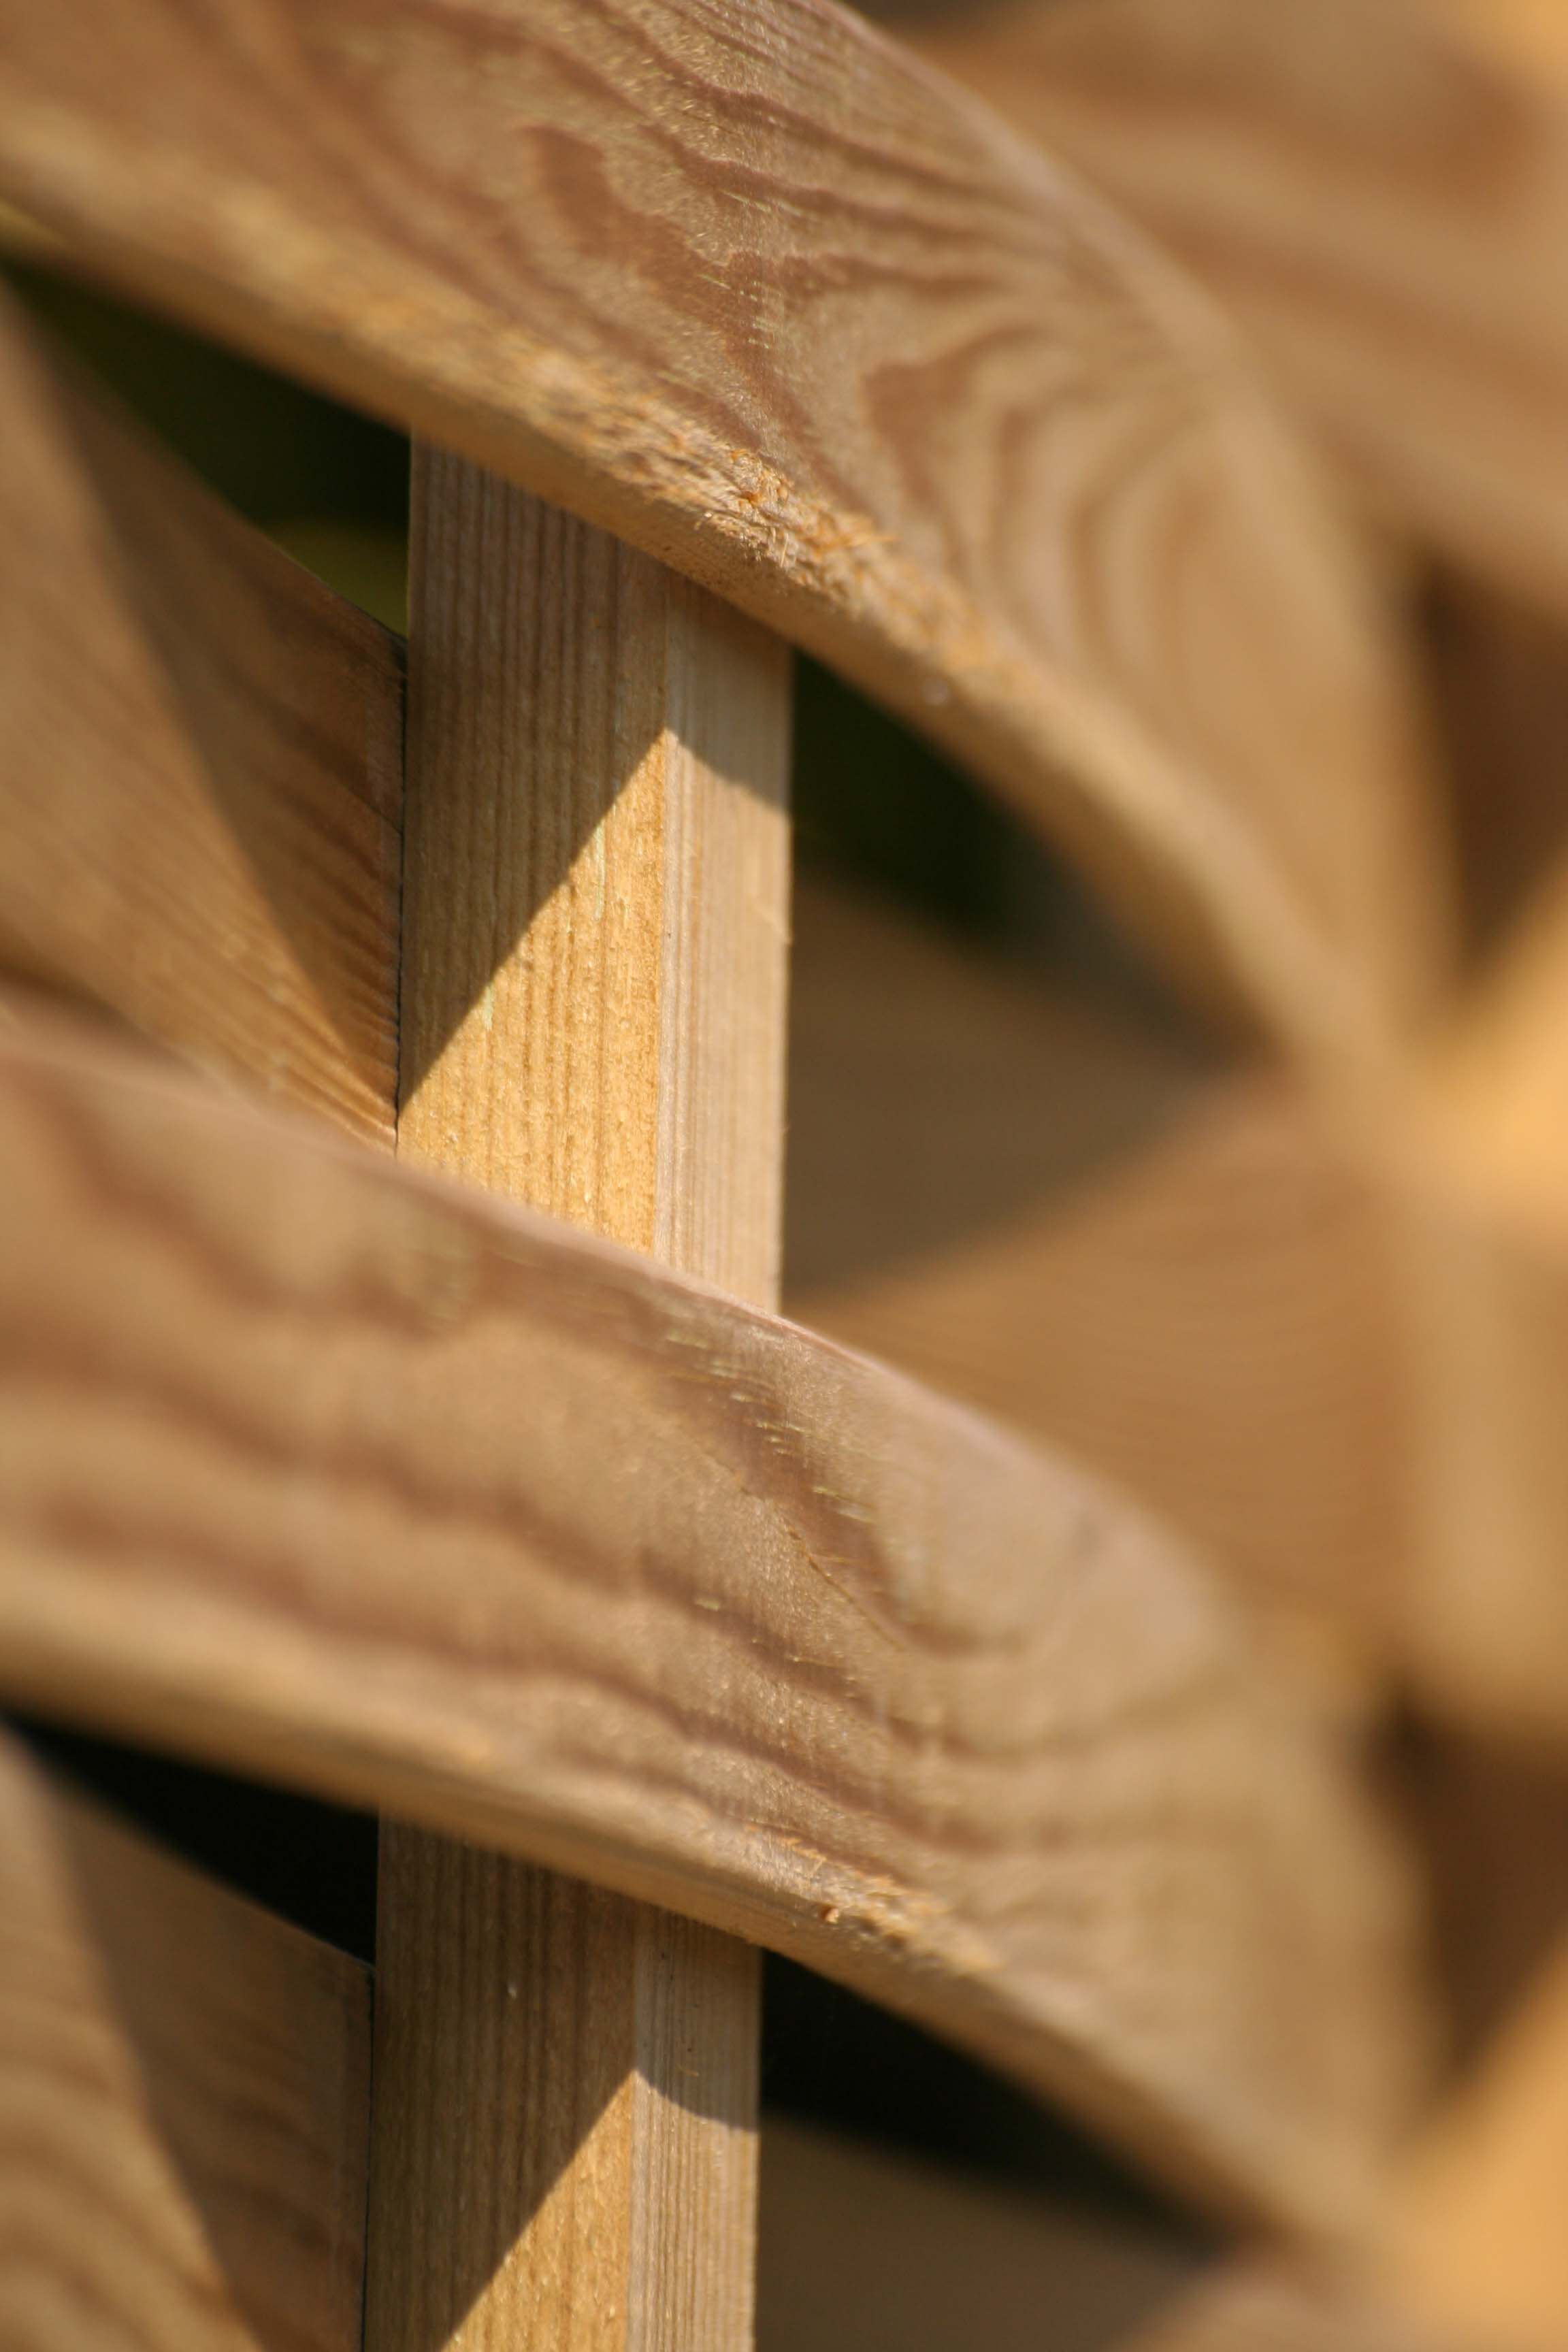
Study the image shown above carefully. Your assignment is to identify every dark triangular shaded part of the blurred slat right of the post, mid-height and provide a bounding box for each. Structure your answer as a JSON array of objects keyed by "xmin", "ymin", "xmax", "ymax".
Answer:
[{"xmin": 785, "ymin": 870, "xmax": 1218, "ymax": 1322}]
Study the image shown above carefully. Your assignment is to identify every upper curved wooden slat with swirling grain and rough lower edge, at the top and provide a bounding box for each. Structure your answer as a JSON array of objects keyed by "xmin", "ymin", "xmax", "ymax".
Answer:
[{"xmin": 0, "ymin": 0, "xmax": 1446, "ymax": 1051}]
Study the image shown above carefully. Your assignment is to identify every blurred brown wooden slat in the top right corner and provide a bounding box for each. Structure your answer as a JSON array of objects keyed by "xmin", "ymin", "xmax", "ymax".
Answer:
[{"xmin": 910, "ymin": 0, "xmax": 1568, "ymax": 614}]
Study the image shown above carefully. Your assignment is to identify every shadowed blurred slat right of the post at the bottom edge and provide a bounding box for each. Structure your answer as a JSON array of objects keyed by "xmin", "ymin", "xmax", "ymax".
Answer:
[{"xmin": 757, "ymin": 2114, "xmax": 1194, "ymax": 2352}]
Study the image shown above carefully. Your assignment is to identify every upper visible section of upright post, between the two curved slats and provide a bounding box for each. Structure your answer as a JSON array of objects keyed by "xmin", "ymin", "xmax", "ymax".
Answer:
[{"xmin": 397, "ymin": 452, "xmax": 790, "ymax": 1305}]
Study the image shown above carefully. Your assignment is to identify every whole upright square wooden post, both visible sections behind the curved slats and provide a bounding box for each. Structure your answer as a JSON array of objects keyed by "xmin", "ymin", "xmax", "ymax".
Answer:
[{"xmin": 369, "ymin": 449, "xmax": 787, "ymax": 2352}]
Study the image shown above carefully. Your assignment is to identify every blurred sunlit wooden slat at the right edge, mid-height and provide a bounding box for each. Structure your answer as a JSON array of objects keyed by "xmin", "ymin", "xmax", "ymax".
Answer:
[{"xmin": 1368, "ymin": 863, "xmax": 1568, "ymax": 1750}]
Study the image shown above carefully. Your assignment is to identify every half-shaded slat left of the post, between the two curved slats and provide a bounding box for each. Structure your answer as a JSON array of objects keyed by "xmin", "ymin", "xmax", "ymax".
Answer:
[{"xmin": 0, "ymin": 292, "xmax": 402, "ymax": 1143}]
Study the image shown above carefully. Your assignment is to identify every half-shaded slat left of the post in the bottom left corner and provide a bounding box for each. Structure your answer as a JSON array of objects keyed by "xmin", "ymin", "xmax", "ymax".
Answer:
[{"xmin": 0, "ymin": 1736, "xmax": 369, "ymax": 2352}]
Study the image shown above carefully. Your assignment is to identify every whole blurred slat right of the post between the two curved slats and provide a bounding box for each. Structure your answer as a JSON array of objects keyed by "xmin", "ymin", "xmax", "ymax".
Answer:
[{"xmin": 787, "ymin": 879, "xmax": 1408, "ymax": 1644}]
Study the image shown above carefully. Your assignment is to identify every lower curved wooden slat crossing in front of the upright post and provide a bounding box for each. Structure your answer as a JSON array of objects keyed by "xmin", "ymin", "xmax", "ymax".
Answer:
[{"xmin": 0, "ymin": 997, "xmax": 1422, "ymax": 2225}]
